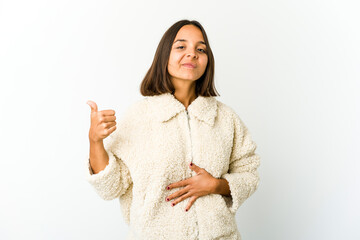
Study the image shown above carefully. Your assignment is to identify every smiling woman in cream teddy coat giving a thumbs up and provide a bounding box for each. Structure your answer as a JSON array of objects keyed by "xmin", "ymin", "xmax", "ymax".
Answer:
[{"xmin": 86, "ymin": 20, "xmax": 260, "ymax": 240}]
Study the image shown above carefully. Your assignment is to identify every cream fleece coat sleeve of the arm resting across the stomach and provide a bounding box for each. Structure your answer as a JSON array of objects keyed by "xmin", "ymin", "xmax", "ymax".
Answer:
[{"xmin": 220, "ymin": 111, "xmax": 260, "ymax": 214}]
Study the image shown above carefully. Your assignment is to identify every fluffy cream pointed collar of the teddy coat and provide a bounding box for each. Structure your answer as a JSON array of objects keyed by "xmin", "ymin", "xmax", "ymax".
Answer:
[{"xmin": 148, "ymin": 93, "xmax": 217, "ymax": 126}]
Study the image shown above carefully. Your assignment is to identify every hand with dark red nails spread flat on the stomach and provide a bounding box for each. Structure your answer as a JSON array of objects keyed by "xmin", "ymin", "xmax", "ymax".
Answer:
[{"xmin": 165, "ymin": 163, "xmax": 217, "ymax": 211}]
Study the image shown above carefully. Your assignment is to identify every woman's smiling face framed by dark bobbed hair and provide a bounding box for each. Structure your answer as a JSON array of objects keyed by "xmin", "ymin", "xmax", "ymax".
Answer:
[{"xmin": 168, "ymin": 25, "xmax": 208, "ymax": 81}]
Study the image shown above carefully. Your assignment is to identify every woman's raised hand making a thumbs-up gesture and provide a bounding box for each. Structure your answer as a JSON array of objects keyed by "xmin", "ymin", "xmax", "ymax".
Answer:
[{"xmin": 86, "ymin": 100, "xmax": 116, "ymax": 142}]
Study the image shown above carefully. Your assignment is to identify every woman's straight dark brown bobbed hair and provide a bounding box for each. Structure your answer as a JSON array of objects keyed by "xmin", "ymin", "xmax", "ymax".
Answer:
[{"xmin": 140, "ymin": 19, "xmax": 220, "ymax": 96}]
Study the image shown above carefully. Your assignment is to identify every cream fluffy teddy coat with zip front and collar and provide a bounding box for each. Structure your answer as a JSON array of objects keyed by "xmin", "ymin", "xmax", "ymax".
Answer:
[{"xmin": 86, "ymin": 93, "xmax": 260, "ymax": 240}]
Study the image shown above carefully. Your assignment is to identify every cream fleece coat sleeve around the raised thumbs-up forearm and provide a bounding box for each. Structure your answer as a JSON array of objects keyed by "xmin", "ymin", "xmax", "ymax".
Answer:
[{"xmin": 85, "ymin": 121, "xmax": 132, "ymax": 200}]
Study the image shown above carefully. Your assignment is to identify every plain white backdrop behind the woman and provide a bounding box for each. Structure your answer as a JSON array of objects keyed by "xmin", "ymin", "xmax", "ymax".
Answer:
[{"xmin": 0, "ymin": 0, "xmax": 360, "ymax": 240}]
